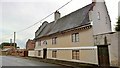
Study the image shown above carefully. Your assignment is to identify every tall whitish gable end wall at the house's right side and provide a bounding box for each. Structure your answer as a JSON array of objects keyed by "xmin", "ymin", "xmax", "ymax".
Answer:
[{"xmin": 89, "ymin": 2, "xmax": 111, "ymax": 35}]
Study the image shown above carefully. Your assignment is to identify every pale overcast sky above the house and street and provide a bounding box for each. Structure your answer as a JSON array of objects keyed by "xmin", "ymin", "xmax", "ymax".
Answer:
[{"xmin": 0, "ymin": 0, "xmax": 120, "ymax": 48}]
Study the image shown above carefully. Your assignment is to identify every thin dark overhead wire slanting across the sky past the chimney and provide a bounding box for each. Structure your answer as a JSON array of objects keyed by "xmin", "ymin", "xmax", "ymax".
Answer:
[{"xmin": 17, "ymin": 0, "xmax": 72, "ymax": 33}]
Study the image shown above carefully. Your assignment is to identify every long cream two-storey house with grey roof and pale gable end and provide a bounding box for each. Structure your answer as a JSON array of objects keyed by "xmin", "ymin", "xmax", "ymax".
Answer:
[{"xmin": 29, "ymin": 0, "xmax": 111, "ymax": 64}]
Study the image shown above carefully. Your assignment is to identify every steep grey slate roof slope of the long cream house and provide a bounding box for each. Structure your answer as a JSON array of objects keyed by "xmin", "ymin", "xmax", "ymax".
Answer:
[{"xmin": 36, "ymin": 3, "xmax": 94, "ymax": 38}]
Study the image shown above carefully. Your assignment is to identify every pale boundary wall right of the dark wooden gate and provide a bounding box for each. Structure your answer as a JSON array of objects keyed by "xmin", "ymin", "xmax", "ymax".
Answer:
[{"xmin": 109, "ymin": 32, "xmax": 120, "ymax": 67}]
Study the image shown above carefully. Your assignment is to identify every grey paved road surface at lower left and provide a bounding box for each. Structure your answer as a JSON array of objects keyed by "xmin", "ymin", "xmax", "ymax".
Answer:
[{"xmin": 0, "ymin": 56, "xmax": 58, "ymax": 66}]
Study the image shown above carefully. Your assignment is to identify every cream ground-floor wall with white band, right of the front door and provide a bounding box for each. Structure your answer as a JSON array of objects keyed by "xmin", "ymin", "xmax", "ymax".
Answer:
[{"xmin": 47, "ymin": 46, "xmax": 98, "ymax": 64}]
